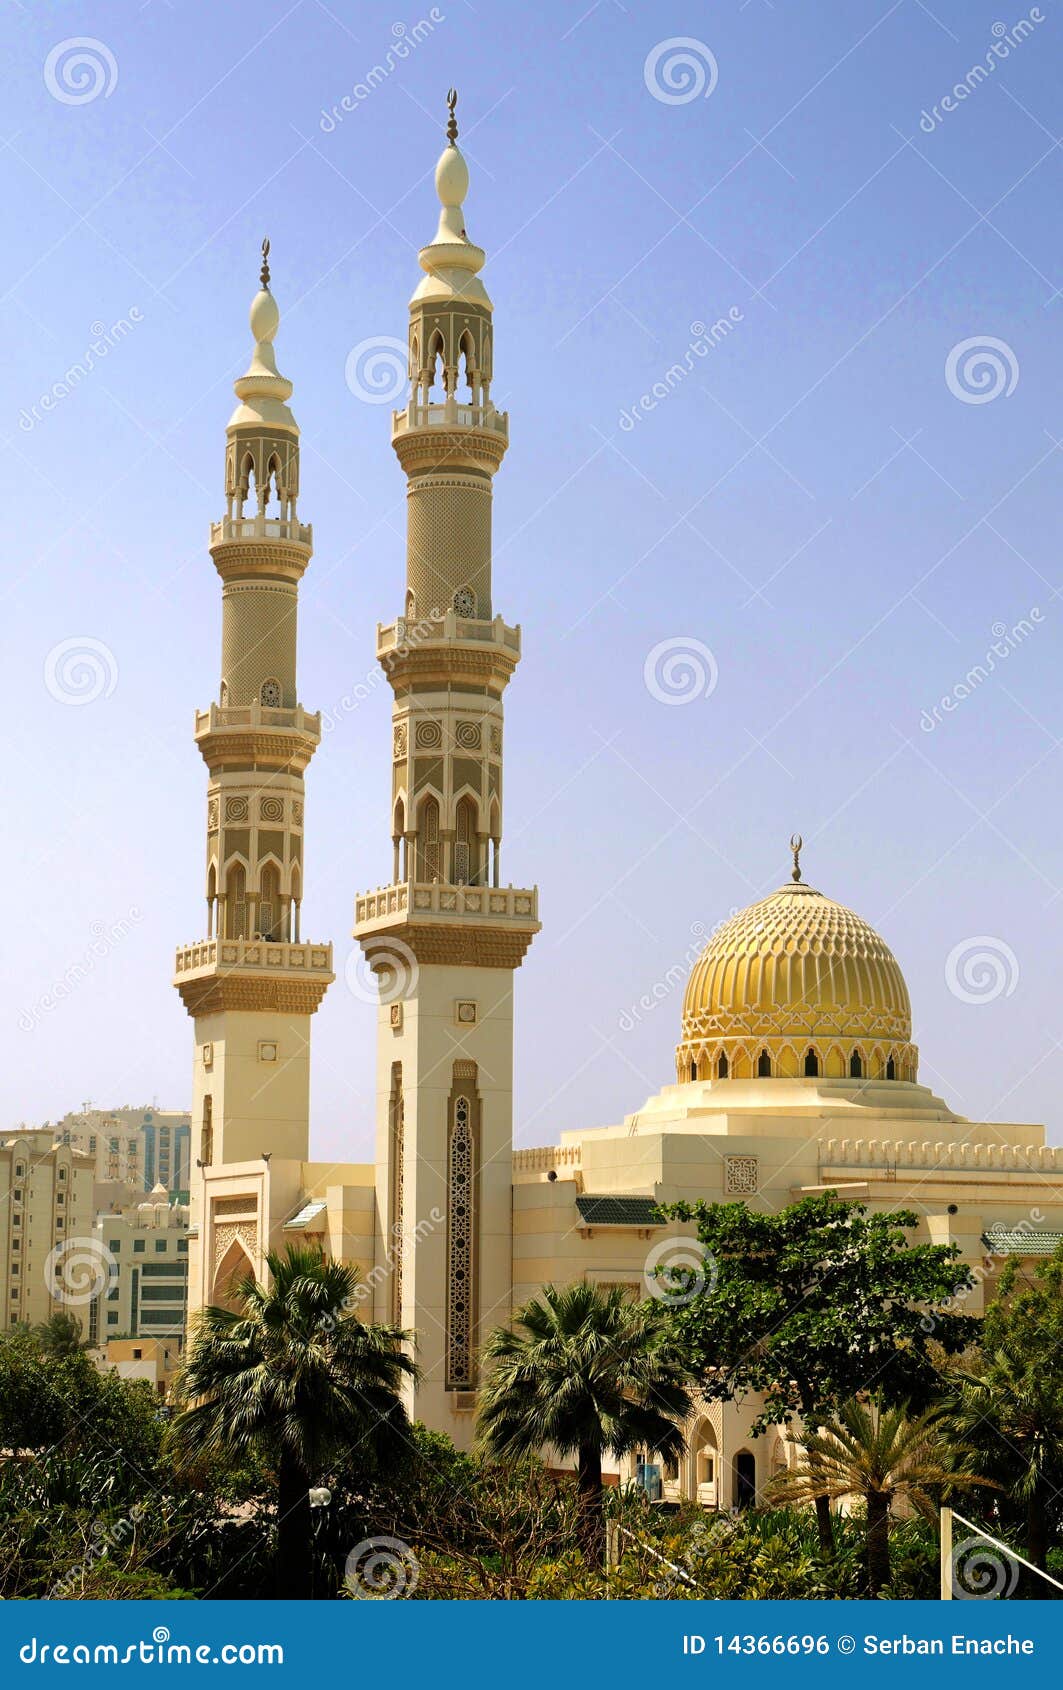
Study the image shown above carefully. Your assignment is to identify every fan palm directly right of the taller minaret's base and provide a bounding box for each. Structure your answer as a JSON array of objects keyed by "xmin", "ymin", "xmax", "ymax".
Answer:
[{"xmin": 478, "ymin": 1283, "xmax": 691, "ymax": 1558}]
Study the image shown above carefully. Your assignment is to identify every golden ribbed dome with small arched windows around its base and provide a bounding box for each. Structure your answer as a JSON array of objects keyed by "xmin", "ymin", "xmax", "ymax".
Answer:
[{"xmin": 676, "ymin": 855, "xmax": 918, "ymax": 1082}]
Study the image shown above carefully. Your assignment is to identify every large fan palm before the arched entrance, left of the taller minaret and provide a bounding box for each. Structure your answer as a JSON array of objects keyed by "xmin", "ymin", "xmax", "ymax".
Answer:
[{"xmin": 169, "ymin": 1244, "xmax": 416, "ymax": 1597}]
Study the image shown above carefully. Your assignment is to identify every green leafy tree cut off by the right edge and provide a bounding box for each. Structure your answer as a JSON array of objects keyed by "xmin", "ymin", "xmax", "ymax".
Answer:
[{"xmin": 953, "ymin": 1247, "xmax": 1063, "ymax": 1575}]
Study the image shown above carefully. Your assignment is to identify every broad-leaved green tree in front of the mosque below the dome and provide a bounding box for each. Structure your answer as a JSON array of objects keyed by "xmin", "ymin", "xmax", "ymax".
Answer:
[{"xmin": 664, "ymin": 1193, "xmax": 979, "ymax": 1553}]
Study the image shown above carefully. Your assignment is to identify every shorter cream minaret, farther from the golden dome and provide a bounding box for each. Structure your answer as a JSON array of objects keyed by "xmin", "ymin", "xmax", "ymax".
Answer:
[{"xmin": 174, "ymin": 242, "xmax": 333, "ymax": 1308}]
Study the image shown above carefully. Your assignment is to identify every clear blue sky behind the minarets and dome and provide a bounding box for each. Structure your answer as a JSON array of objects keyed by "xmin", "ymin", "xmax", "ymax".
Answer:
[{"xmin": 0, "ymin": 0, "xmax": 1063, "ymax": 1158}]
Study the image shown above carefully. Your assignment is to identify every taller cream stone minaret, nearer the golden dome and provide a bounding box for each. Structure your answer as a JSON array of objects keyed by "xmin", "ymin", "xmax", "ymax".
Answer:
[{"xmin": 355, "ymin": 90, "xmax": 539, "ymax": 1443}]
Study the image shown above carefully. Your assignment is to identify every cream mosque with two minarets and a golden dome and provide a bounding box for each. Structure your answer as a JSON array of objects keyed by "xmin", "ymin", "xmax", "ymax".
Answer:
[{"xmin": 176, "ymin": 100, "xmax": 1063, "ymax": 1507}]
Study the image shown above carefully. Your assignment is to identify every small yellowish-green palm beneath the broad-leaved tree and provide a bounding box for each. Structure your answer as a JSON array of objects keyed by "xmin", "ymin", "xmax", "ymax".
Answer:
[{"xmin": 767, "ymin": 1398, "xmax": 990, "ymax": 1597}]
